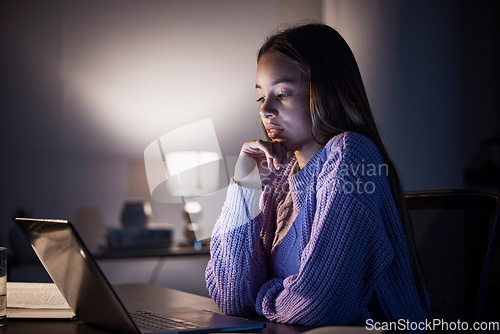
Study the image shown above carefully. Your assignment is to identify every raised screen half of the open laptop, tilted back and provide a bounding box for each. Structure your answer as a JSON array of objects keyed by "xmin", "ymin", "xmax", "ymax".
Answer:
[{"xmin": 16, "ymin": 218, "xmax": 139, "ymax": 333}]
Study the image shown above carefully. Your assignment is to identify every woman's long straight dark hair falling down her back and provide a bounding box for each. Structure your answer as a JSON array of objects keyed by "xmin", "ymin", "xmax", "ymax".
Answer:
[{"xmin": 257, "ymin": 24, "xmax": 426, "ymax": 314}]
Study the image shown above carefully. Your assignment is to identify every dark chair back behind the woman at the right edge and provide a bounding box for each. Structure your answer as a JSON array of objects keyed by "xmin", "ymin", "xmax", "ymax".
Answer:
[{"xmin": 405, "ymin": 190, "xmax": 500, "ymax": 322}]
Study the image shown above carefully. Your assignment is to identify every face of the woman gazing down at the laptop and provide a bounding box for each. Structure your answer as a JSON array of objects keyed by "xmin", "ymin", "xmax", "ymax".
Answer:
[{"xmin": 255, "ymin": 53, "xmax": 316, "ymax": 151}]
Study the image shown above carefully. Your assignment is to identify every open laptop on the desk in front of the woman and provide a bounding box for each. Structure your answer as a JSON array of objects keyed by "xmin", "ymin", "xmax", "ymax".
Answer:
[{"xmin": 16, "ymin": 218, "xmax": 265, "ymax": 333}]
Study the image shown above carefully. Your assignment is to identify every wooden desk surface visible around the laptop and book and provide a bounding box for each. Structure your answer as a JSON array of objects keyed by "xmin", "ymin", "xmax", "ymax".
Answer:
[{"xmin": 0, "ymin": 284, "xmax": 311, "ymax": 334}]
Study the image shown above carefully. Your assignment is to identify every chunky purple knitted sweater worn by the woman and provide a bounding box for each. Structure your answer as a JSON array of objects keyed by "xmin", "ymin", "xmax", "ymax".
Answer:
[{"xmin": 206, "ymin": 132, "xmax": 427, "ymax": 326}]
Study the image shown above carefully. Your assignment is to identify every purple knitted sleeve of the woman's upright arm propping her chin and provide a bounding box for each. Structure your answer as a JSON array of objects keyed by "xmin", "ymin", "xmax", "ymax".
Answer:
[{"xmin": 205, "ymin": 182, "xmax": 267, "ymax": 316}]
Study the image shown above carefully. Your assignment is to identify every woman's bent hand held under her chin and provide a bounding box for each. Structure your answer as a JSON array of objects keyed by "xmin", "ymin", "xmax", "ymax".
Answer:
[{"xmin": 233, "ymin": 140, "xmax": 293, "ymax": 189}]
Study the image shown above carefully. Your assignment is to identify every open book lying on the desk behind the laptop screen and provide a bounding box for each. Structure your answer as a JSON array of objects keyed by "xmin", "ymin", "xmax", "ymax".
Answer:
[{"xmin": 7, "ymin": 282, "xmax": 71, "ymax": 311}]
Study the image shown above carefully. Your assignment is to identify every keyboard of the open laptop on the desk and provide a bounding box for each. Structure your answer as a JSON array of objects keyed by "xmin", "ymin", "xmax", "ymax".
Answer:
[{"xmin": 130, "ymin": 311, "xmax": 201, "ymax": 332}]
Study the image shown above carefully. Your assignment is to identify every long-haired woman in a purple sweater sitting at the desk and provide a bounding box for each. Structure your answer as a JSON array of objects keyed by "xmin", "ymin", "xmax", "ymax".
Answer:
[{"xmin": 206, "ymin": 24, "xmax": 428, "ymax": 326}]
